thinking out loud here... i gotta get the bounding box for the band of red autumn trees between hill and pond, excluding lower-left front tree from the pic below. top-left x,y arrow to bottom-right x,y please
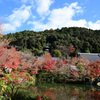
0,40 -> 100,82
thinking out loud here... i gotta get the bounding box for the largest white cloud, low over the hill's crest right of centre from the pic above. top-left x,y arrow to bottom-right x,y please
28,2 -> 87,30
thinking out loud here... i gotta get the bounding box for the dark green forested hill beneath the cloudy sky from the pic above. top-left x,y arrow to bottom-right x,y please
4,27 -> 100,55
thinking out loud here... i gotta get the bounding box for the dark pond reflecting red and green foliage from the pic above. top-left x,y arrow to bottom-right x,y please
36,83 -> 100,100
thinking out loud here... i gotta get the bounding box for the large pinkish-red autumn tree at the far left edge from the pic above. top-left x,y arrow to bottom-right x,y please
0,40 -> 21,70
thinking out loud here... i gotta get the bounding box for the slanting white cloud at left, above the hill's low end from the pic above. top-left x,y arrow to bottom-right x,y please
4,5 -> 31,31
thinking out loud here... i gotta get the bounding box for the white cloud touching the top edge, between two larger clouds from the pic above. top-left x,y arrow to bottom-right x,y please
35,0 -> 53,16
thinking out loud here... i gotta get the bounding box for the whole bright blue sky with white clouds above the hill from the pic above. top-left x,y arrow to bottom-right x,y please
0,0 -> 100,34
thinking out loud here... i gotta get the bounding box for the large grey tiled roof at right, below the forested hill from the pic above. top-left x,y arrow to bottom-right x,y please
78,53 -> 100,62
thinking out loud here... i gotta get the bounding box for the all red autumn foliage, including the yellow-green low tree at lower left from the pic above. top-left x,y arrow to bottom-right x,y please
0,40 -> 100,100
